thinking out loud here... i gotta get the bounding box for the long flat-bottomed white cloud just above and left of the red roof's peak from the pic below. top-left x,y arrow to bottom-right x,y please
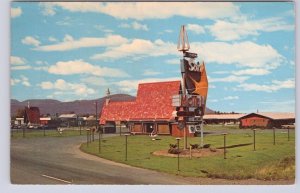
48,60 -> 129,77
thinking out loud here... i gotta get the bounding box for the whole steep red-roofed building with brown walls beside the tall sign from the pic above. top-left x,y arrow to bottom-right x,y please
99,80 -> 194,137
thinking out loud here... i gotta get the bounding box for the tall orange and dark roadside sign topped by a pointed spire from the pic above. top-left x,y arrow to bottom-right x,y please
173,25 -> 208,149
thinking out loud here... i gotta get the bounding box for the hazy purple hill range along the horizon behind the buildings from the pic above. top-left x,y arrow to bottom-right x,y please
10,94 -> 215,115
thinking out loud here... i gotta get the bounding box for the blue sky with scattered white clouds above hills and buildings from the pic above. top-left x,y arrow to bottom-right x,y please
10,2 -> 295,112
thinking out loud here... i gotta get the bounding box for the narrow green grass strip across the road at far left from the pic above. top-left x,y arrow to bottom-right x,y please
11,129 -> 90,139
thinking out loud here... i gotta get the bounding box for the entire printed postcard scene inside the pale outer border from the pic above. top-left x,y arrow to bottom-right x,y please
10,1 -> 296,185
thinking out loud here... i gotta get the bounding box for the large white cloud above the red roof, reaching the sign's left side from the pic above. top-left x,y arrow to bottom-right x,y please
91,39 -> 179,59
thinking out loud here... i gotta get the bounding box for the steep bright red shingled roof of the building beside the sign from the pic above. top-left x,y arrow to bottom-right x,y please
100,81 -> 180,124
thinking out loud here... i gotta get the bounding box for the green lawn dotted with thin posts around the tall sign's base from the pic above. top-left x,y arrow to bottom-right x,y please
81,127 -> 295,180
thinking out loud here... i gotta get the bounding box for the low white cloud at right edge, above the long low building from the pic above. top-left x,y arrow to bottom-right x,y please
238,79 -> 295,92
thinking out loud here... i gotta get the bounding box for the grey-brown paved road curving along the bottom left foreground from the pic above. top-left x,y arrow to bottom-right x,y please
11,133 -> 289,184
